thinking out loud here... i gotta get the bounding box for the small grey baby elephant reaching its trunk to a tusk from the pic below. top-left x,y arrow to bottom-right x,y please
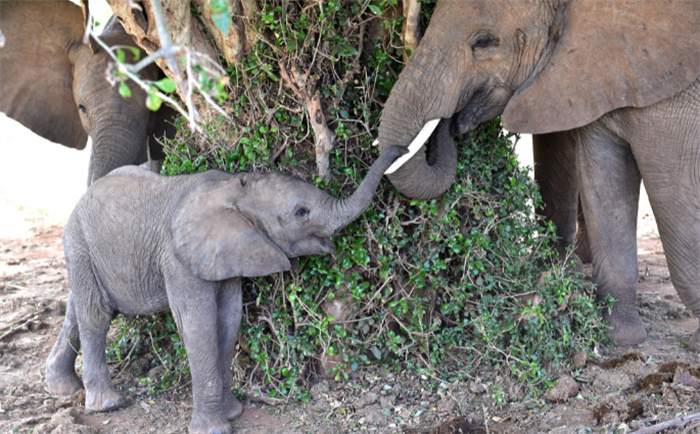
46,148 -> 404,433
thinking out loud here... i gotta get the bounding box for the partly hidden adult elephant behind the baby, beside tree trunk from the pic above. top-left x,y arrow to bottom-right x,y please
0,0 -> 176,185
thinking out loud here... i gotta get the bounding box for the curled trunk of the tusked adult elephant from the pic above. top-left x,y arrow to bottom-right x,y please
378,28 -> 463,199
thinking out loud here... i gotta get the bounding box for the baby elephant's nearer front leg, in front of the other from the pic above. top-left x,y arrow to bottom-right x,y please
166,267 -> 231,434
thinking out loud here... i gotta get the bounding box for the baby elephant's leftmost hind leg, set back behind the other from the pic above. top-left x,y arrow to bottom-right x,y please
46,294 -> 83,395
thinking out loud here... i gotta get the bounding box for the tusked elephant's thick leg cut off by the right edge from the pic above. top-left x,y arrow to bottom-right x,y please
628,92 -> 700,352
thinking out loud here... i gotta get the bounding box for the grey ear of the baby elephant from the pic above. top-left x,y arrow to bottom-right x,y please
171,178 -> 291,281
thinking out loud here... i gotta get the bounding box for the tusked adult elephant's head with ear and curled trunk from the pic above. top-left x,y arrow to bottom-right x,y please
378,0 -> 700,199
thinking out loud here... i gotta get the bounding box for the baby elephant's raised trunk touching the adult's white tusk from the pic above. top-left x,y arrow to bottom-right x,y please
325,146 -> 405,233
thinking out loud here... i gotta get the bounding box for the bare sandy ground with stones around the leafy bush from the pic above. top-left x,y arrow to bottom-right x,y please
0,119 -> 700,434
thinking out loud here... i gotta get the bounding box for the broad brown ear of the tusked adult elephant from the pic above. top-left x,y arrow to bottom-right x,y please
503,0 -> 700,133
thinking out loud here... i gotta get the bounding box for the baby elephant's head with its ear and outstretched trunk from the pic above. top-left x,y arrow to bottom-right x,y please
171,147 -> 405,280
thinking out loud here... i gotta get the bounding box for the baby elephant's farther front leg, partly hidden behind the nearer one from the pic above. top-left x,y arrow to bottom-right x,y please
217,277 -> 243,420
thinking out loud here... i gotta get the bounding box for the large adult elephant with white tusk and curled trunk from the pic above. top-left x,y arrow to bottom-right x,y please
378,0 -> 700,351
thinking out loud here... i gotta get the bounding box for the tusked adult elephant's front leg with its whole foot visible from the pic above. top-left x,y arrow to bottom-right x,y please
575,122 -> 647,345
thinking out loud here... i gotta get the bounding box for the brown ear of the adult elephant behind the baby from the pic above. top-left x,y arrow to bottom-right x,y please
0,1 -> 88,149
